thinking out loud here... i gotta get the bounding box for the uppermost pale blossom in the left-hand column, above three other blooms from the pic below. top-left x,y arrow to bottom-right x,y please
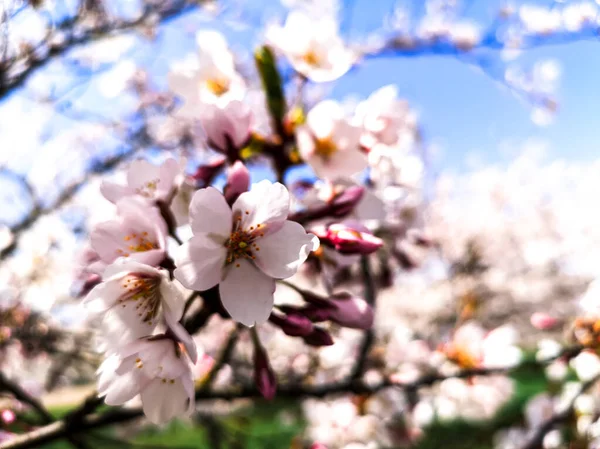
100,159 -> 181,203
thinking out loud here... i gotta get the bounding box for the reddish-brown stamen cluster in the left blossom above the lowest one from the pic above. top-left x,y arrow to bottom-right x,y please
119,273 -> 161,326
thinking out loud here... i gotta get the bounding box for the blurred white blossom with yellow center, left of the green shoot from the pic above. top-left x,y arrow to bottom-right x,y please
168,31 -> 246,114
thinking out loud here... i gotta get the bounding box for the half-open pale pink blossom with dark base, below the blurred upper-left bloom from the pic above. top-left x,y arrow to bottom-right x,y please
200,100 -> 252,155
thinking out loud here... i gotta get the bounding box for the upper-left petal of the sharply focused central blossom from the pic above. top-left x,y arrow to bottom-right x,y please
190,187 -> 232,241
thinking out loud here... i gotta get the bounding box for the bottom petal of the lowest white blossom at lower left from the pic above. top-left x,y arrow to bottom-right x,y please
140,379 -> 189,424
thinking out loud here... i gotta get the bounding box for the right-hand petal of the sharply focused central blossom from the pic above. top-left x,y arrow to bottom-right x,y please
255,221 -> 319,279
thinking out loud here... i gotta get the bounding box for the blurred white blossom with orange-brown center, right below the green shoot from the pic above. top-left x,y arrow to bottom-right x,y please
296,100 -> 367,180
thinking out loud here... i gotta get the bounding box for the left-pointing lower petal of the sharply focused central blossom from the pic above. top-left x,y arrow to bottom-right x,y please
174,235 -> 227,291
